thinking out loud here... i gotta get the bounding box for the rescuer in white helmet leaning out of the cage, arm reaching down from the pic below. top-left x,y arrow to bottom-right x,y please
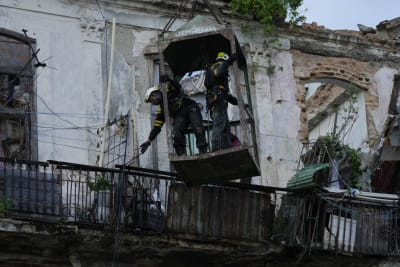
140,75 -> 207,156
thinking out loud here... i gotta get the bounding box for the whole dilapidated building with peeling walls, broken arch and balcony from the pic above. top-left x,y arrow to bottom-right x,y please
0,0 -> 400,266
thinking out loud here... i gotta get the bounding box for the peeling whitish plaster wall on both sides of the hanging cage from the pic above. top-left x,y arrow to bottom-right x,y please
0,0 -> 300,186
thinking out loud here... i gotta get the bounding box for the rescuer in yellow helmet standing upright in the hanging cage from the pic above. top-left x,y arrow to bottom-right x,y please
204,52 -> 238,151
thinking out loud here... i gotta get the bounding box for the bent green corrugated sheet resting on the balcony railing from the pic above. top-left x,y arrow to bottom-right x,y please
286,163 -> 330,189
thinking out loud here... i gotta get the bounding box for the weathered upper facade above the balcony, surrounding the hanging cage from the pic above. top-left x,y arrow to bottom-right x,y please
0,0 -> 400,266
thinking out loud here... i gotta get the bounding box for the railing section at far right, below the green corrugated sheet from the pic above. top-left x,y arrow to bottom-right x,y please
281,194 -> 400,256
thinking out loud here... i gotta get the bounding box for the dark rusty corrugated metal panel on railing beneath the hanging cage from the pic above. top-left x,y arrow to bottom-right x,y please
167,184 -> 275,241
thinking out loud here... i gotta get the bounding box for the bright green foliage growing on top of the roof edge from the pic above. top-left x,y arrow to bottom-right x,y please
231,0 -> 306,34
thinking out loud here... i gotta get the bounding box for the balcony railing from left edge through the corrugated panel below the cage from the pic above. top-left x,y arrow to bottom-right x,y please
0,158 -> 275,241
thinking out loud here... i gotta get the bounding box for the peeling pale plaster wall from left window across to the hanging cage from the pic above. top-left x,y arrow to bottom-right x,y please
0,0 -> 175,168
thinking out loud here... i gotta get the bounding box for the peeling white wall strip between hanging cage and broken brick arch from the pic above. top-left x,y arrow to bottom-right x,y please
248,39 -> 301,187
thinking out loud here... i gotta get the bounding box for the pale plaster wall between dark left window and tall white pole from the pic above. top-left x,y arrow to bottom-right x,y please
0,1 -> 102,162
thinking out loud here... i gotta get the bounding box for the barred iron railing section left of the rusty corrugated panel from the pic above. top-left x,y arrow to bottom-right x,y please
0,158 -> 175,231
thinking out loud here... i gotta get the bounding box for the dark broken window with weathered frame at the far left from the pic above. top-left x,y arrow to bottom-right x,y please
0,28 -> 38,160
